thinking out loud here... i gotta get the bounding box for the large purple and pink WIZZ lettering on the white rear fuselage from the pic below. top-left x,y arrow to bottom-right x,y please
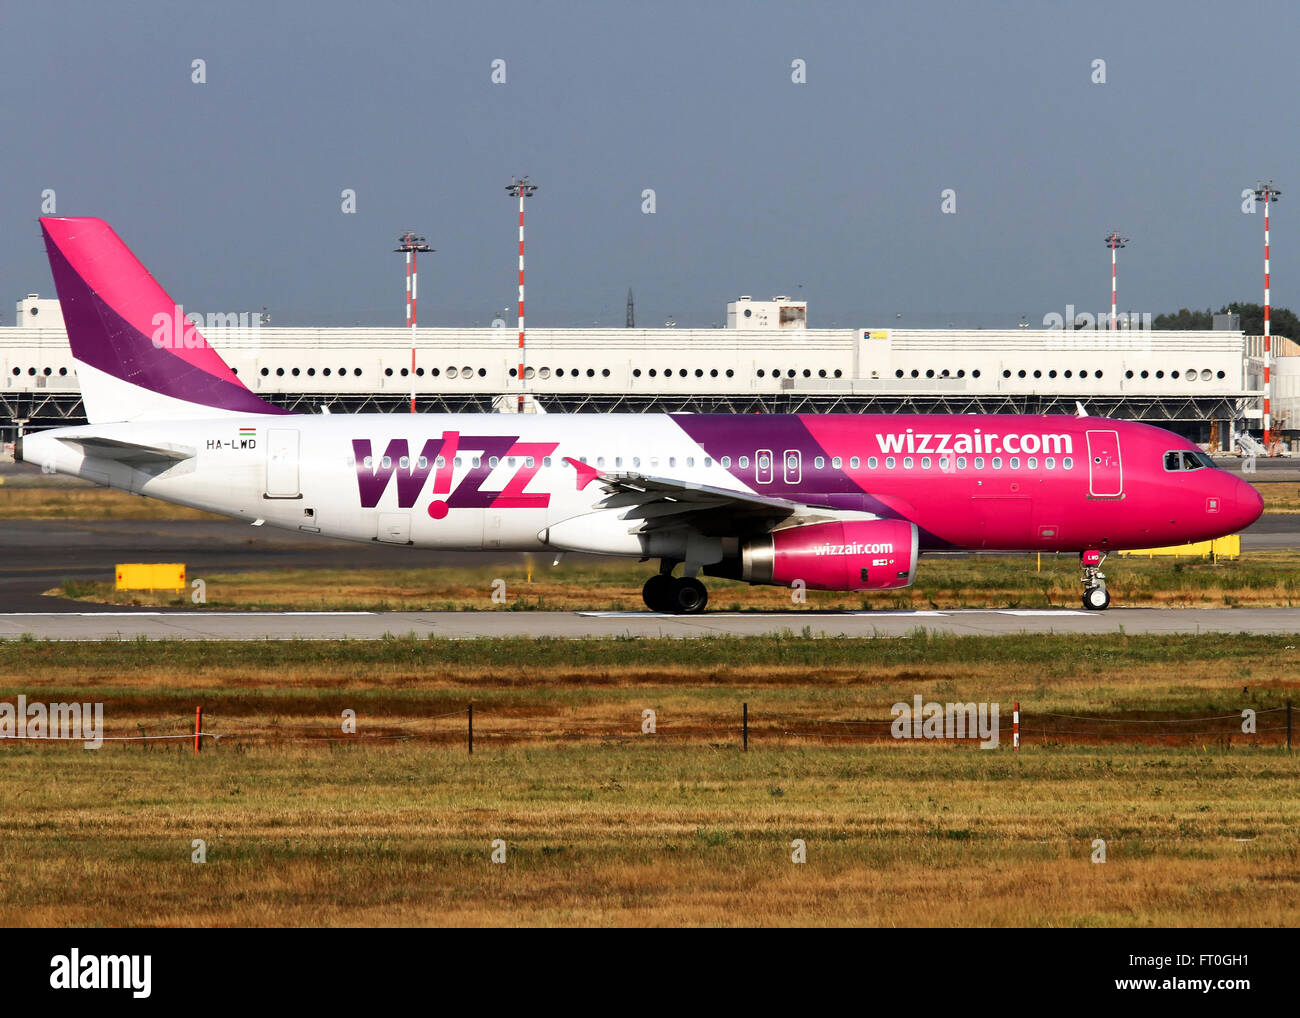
352,432 -> 559,519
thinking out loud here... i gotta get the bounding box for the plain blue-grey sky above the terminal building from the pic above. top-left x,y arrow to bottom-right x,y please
0,0 -> 1300,328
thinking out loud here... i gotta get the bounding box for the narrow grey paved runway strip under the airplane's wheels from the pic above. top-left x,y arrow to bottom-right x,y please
0,606 -> 1300,642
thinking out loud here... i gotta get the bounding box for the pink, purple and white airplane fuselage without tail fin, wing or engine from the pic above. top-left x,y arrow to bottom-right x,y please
22,413 -> 1262,555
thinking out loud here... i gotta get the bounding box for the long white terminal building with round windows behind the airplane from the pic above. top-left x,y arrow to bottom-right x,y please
0,294 -> 1284,450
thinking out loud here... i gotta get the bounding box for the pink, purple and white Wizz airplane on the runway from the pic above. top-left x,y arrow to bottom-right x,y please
18,217 -> 1262,614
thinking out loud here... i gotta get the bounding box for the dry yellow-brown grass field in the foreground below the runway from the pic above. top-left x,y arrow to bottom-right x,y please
0,636 -> 1300,926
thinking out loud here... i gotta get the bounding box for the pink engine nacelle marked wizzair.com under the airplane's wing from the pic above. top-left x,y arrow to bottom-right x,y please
740,520 -> 918,590
